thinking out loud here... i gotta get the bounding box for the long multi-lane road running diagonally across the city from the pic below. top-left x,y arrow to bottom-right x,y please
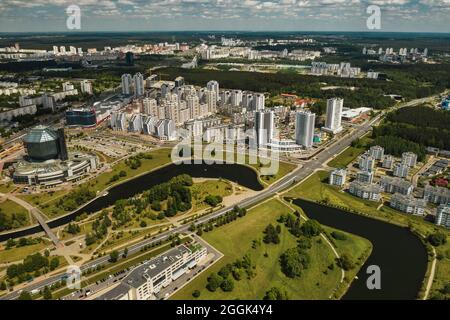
0,98 -> 436,300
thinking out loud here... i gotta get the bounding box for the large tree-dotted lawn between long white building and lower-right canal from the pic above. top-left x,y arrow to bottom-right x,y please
172,199 -> 340,300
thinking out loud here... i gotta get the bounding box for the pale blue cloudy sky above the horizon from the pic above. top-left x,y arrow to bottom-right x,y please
0,0 -> 450,33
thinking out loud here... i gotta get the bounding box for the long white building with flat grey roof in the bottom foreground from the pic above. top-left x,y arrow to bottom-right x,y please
98,244 -> 207,300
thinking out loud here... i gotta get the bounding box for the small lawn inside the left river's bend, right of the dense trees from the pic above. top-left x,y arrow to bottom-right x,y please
190,179 -> 233,211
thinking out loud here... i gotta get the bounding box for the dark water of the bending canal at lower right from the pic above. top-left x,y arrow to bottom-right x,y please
294,199 -> 427,300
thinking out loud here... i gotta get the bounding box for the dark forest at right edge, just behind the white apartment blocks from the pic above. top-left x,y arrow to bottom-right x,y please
373,106 -> 450,150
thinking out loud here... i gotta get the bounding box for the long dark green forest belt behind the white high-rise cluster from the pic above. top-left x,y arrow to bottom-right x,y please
157,64 -> 450,109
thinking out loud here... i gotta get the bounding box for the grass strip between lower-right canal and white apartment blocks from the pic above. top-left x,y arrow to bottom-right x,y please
285,171 -> 450,298
